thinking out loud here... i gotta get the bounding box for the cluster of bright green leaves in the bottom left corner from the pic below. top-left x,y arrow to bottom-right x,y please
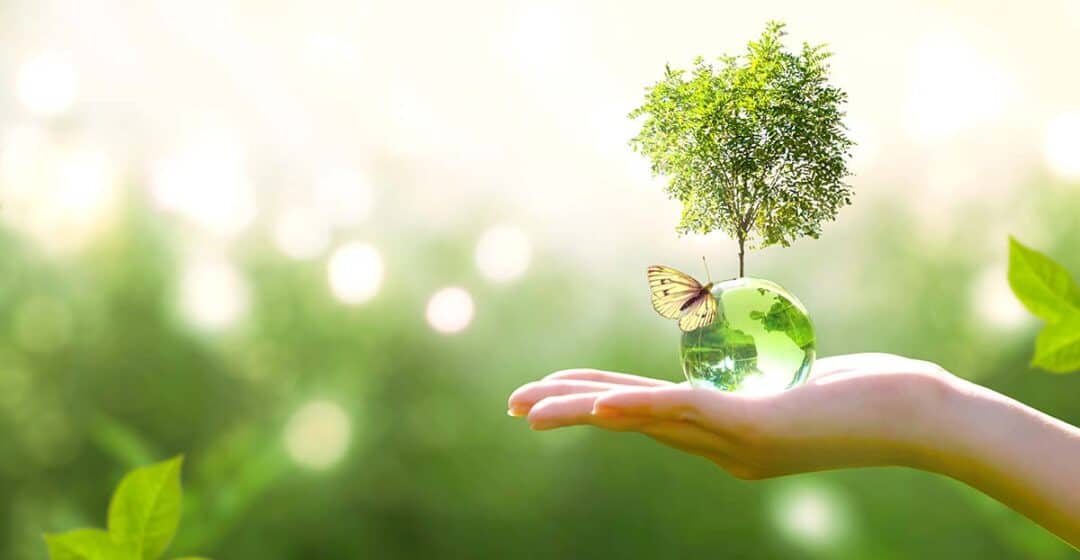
45,456 -> 206,560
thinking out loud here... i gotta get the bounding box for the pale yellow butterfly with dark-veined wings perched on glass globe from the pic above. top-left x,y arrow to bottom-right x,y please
648,264 -> 717,332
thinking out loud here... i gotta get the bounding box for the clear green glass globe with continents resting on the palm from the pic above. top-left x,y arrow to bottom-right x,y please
681,277 -> 814,393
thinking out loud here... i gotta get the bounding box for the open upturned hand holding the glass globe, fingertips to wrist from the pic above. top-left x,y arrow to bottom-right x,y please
509,354 -> 954,479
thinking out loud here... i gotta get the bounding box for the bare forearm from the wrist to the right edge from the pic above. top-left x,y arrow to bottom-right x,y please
924,380 -> 1080,547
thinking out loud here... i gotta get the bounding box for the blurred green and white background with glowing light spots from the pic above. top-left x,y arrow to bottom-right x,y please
0,1 -> 1080,559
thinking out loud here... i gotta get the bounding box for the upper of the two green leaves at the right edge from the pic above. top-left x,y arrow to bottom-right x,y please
1009,237 -> 1080,323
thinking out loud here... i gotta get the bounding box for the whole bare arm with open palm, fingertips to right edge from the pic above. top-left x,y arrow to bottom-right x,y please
508,354 -> 1080,548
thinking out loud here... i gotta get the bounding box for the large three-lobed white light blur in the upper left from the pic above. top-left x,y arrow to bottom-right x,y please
150,127 -> 256,237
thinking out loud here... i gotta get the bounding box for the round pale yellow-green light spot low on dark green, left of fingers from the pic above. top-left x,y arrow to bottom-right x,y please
285,400 -> 352,470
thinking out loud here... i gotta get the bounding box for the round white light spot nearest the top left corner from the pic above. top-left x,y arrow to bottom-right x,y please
16,53 -> 79,117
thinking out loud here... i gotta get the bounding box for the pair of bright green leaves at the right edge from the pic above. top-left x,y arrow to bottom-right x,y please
1009,237 -> 1080,373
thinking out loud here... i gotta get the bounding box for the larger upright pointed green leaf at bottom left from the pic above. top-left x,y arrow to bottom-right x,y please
109,456 -> 184,560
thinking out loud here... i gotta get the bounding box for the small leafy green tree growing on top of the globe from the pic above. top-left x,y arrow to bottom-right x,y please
630,22 -> 854,276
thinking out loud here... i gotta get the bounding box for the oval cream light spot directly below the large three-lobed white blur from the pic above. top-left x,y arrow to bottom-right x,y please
180,255 -> 249,330
